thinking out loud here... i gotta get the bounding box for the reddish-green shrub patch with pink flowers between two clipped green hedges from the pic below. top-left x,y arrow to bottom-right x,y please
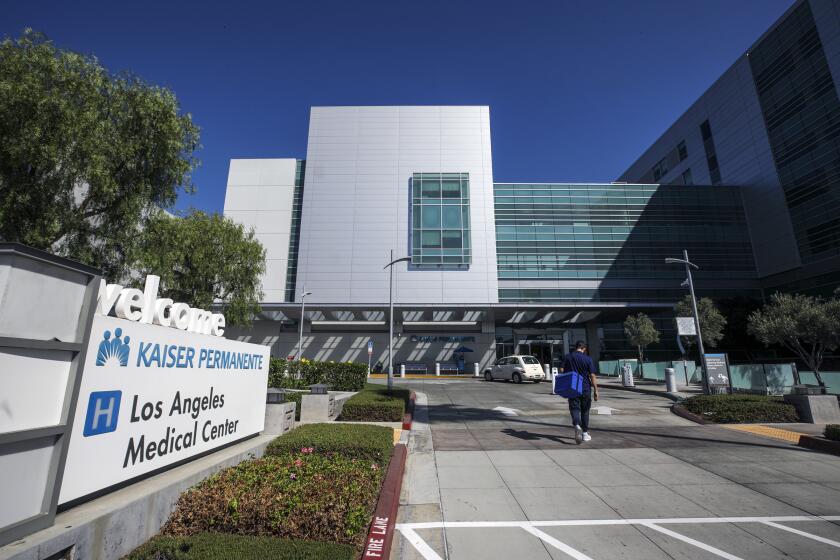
161,450 -> 384,548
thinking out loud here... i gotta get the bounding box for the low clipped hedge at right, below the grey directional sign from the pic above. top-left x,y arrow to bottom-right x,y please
682,395 -> 799,424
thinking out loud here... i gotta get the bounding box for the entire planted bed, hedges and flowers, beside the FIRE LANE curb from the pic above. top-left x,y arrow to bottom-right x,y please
128,424 -> 394,560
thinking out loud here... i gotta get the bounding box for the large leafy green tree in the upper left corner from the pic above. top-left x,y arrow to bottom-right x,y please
0,29 -> 199,280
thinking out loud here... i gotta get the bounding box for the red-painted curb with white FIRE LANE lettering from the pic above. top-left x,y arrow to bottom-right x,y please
362,443 -> 408,560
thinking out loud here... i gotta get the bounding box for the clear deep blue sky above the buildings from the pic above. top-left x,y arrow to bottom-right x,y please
0,0 -> 793,211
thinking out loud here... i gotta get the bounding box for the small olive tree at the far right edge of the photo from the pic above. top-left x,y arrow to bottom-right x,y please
748,292 -> 840,393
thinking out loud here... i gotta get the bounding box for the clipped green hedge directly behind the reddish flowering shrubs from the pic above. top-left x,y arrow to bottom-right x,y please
265,424 -> 394,466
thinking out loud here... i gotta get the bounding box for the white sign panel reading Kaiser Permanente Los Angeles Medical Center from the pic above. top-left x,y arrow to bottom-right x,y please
59,312 -> 269,503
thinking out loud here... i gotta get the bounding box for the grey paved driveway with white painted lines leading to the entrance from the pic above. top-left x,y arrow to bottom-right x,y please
391,380 -> 840,560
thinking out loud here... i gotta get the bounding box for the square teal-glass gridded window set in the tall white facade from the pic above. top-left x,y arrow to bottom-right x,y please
411,173 -> 471,268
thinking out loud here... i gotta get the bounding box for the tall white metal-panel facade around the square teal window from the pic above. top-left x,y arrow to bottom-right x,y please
296,106 -> 498,304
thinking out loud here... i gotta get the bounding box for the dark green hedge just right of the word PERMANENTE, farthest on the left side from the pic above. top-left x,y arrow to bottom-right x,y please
268,358 -> 367,391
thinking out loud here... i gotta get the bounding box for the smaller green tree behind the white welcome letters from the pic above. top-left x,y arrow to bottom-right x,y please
133,211 -> 265,326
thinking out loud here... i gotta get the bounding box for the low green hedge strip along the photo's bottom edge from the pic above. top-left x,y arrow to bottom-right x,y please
125,533 -> 356,560
